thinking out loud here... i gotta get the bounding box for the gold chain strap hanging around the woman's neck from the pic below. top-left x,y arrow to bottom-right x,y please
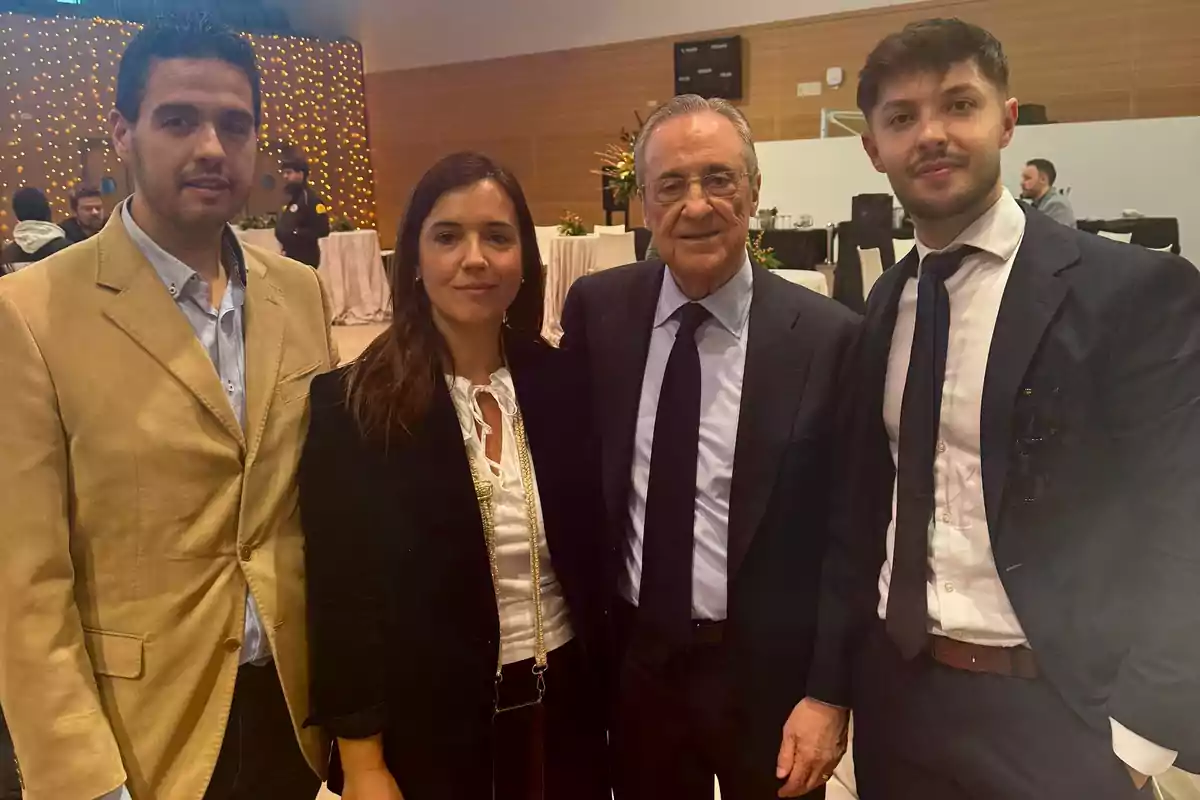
467,409 -> 547,686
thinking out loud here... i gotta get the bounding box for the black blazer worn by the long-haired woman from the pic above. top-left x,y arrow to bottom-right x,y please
299,333 -> 604,800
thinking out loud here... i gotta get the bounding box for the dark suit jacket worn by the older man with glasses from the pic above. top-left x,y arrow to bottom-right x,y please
563,261 -> 859,777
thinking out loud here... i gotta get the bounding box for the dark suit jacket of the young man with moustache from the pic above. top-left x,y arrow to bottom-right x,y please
817,211 -> 1200,770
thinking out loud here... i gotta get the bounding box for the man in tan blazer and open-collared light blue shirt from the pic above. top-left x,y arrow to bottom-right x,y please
0,15 -> 337,800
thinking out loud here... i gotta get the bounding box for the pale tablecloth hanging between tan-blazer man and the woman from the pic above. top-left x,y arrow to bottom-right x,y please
318,230 -> 391,325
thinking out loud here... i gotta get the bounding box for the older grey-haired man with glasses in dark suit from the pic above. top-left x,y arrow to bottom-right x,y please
563,96 -> 858,800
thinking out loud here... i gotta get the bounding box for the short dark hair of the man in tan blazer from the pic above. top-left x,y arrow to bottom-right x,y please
116,14 -> 263,127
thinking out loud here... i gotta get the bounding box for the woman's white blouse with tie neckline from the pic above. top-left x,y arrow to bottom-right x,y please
446,367 -> 574,664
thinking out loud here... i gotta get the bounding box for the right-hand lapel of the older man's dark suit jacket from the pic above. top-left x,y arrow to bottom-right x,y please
728,266 -> 812,582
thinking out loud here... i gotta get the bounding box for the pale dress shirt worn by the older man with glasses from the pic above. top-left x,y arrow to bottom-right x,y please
623,255 -> 754,620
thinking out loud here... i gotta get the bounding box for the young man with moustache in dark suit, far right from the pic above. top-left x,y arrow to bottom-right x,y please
801,14 -> 1200,800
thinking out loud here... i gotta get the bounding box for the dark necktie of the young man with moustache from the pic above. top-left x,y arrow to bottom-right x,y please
886,247 -> 978,658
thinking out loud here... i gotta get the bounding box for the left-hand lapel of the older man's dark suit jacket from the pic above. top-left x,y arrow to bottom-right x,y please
601,261 -> 666,530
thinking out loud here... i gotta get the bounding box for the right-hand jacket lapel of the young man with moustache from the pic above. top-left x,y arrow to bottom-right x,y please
979,213 -> 1080,537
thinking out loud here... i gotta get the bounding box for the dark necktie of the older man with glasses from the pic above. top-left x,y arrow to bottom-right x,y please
638,302 -> 709,643
